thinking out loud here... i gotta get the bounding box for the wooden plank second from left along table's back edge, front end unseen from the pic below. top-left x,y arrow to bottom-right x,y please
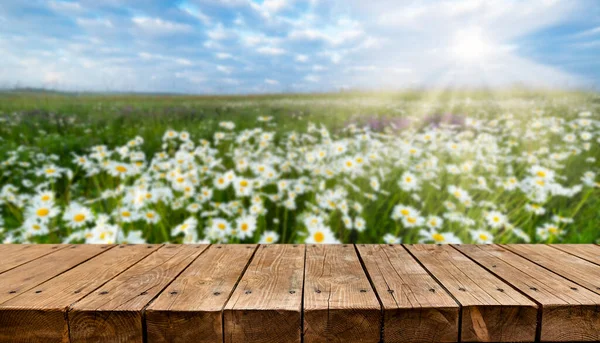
0,245 -> 112,304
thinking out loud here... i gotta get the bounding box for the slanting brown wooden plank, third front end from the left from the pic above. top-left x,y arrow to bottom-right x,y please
146,244 -> 257,343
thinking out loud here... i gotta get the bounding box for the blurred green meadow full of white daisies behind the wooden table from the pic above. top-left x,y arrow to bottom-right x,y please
0,93 -> 600,243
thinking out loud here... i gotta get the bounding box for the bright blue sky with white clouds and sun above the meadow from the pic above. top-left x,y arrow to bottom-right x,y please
0,0 -> 600,94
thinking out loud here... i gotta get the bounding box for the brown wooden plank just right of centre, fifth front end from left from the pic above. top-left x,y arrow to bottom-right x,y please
304,244 -> 382,342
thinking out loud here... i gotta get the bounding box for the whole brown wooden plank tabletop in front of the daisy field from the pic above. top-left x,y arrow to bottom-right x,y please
0,244 -> 600,343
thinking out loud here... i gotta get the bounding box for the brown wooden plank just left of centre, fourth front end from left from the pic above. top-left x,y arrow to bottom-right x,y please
223,244 -> 305,343
